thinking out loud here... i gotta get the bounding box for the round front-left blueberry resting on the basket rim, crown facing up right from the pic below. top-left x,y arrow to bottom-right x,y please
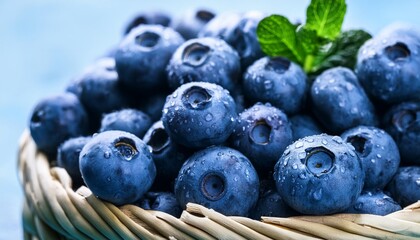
79,131 -> 156,205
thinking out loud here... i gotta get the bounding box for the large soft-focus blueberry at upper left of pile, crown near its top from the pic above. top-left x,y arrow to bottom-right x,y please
115,25 -> 184,94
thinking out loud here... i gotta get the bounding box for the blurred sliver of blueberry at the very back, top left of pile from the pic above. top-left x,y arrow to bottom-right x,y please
124,11 -> 171,35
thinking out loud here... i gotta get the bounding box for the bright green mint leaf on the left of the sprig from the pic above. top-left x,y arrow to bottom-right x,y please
257,15 -> 304,63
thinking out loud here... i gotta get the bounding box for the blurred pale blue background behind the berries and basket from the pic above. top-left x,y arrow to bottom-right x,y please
0,0 -> 420,239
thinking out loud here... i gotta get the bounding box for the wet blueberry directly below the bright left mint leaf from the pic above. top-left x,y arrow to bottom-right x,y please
243,57 -> 306,114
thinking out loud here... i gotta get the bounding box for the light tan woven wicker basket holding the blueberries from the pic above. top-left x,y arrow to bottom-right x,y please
18,131 -> 420,240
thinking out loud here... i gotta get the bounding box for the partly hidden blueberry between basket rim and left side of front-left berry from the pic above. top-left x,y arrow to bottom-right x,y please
57,137 -> 91,189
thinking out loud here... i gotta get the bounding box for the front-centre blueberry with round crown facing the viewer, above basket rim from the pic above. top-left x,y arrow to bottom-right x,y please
175,146 -> 259,216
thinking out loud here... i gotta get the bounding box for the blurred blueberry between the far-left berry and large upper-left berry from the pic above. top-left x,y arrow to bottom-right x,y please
66,58 -> 129,128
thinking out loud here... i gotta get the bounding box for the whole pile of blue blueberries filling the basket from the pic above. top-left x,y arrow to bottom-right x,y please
29,10 -> 420,219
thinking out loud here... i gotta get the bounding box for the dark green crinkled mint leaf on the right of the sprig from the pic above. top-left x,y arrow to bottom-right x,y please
311,30 -> 372,74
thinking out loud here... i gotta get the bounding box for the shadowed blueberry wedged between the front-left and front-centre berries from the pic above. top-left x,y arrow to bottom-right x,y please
143,121 -> 191,191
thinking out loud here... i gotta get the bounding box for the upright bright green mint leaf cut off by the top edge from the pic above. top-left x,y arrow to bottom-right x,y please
305,0 -> 347,40
